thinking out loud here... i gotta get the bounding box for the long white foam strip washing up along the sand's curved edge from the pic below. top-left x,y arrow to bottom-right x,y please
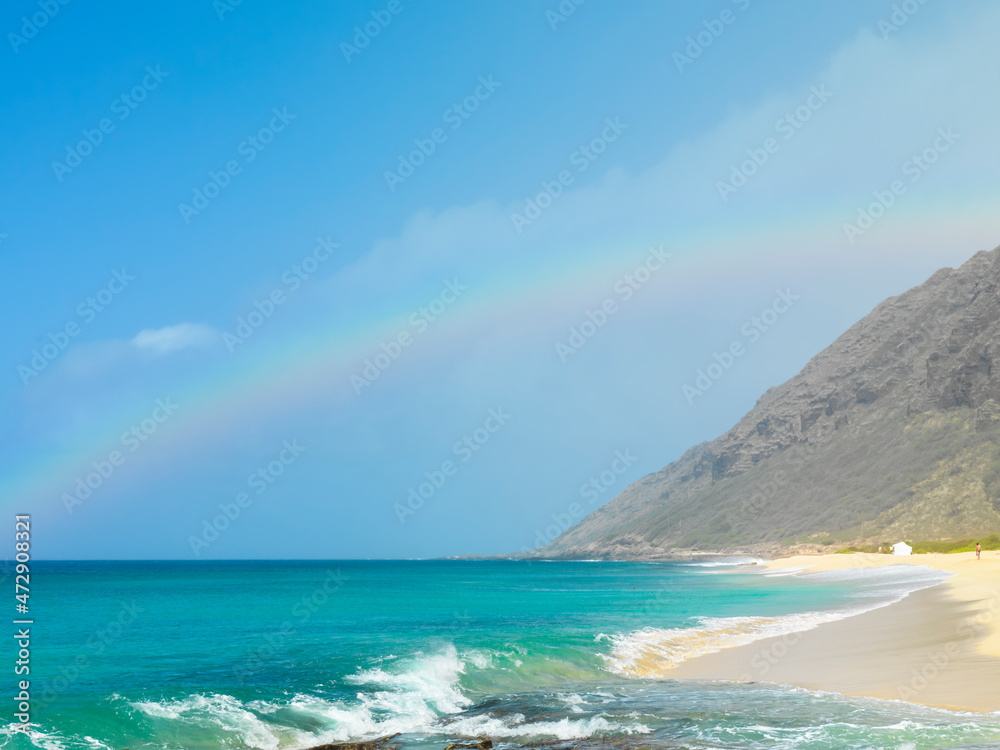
597,565 -> 951,677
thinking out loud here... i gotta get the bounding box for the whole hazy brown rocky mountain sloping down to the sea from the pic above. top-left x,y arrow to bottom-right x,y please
531,248 -> 1000,559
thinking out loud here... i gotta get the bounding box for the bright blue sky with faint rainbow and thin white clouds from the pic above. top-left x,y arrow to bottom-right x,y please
0,0 -> 1000,559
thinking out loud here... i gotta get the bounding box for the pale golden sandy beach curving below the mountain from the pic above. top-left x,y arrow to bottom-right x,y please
669,551 -> 1000,712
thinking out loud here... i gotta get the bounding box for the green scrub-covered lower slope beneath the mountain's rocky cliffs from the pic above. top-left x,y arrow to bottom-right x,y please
636,408 -> 1000,549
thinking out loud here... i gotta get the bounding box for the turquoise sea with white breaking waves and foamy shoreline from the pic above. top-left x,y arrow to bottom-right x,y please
2,561 -> 1000,750
